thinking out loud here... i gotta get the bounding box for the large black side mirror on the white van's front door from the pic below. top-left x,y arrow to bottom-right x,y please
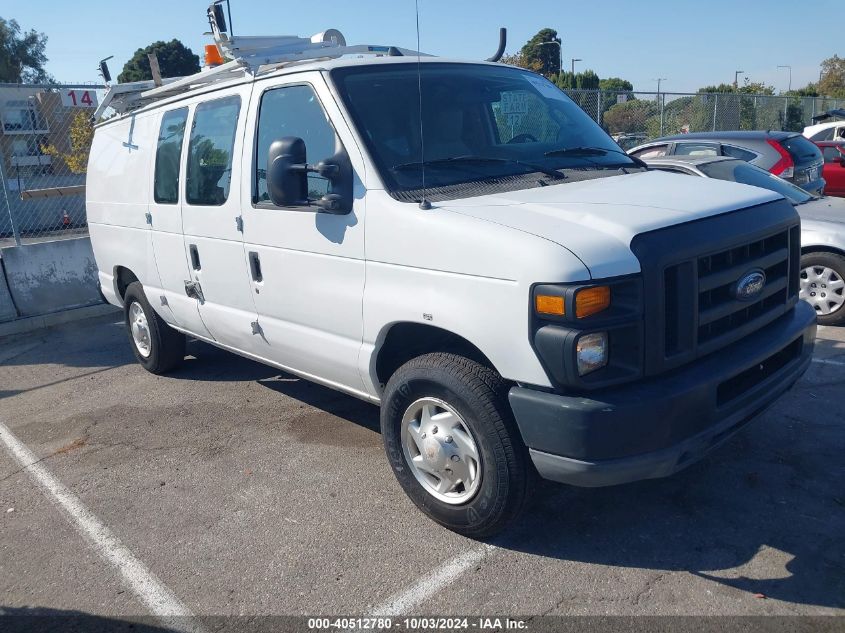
267,136 -> 352,215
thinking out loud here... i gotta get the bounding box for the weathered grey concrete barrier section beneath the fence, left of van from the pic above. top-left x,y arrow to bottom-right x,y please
0,237 -> 102,317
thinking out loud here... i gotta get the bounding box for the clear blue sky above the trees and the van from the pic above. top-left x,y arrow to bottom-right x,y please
6,0 -> 843,91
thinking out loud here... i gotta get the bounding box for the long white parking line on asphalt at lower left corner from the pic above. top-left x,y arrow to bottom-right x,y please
0,422 -> 206,633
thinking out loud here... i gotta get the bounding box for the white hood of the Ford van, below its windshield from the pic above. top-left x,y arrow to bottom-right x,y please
437,171 -> 781,279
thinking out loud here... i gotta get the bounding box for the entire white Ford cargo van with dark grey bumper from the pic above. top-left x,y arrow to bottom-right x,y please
87,14 -> 816,536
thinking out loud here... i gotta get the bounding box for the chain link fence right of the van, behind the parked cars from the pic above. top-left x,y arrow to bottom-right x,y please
565,90 -> 845,149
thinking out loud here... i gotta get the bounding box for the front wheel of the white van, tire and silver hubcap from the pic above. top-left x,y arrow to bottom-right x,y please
381,353 -> 533,538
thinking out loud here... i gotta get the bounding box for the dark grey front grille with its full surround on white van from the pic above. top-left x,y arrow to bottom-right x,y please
631,200 -> 801,376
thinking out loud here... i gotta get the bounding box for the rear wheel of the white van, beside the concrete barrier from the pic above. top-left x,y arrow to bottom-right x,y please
123,281 -> 185,375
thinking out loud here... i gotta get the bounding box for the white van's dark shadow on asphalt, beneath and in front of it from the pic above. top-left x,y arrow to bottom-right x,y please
176,341 -> 845,608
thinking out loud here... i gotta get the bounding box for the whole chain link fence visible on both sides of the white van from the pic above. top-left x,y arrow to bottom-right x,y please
0,84 -> 845,246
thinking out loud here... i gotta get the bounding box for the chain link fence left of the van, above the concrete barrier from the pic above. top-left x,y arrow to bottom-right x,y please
0,84 -> 105,246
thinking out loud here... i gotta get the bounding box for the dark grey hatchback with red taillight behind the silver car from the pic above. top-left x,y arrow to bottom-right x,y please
628,132 -> 825,194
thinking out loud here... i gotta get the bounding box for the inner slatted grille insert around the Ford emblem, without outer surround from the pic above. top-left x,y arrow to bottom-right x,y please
664,226 -> 800,357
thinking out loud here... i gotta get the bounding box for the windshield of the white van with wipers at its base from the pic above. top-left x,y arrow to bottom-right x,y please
331,61 -> 637,199
